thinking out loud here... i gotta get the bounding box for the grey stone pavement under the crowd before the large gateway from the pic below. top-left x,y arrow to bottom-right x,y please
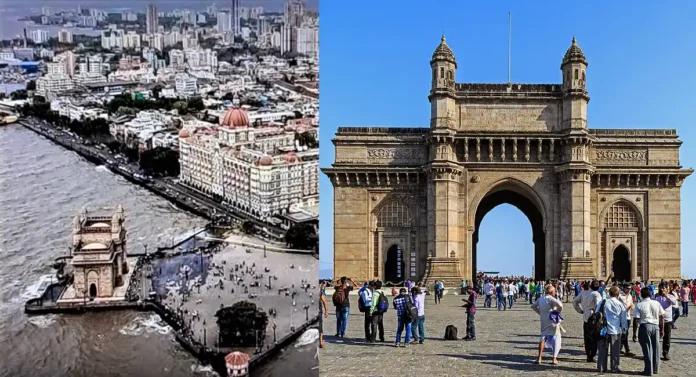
320,291 -> 696,377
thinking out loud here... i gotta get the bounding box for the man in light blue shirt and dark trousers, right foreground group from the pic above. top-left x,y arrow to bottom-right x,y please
595,286 -> 628,373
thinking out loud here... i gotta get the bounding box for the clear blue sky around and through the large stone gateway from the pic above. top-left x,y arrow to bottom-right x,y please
320,0 -> 696,277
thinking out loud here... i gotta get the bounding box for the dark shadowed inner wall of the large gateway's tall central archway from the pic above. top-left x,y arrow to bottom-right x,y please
472,190 -> 546,281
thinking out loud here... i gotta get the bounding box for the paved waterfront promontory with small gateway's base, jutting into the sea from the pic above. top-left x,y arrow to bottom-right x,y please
25,208 -> 318,376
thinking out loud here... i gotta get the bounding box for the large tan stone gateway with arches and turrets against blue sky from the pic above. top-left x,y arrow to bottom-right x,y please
323,36 -> 693,285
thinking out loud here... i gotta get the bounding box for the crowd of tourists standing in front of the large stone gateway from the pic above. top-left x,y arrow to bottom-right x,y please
322,274 -> 696,375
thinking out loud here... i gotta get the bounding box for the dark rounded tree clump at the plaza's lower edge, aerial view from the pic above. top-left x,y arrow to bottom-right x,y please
215,301 -> 268,347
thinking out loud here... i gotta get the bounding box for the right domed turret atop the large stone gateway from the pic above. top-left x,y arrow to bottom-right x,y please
561,37 -> 590,130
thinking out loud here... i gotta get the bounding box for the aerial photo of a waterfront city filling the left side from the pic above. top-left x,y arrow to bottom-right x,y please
0,0 -> 320,376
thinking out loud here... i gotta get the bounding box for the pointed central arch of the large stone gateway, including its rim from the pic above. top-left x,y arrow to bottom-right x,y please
471,178 -> 547,281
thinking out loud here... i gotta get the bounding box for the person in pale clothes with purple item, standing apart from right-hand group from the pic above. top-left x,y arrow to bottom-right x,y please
532,284 -> 563,365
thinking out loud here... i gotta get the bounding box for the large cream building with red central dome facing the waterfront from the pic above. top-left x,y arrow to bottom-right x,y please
179,109 -> 319,222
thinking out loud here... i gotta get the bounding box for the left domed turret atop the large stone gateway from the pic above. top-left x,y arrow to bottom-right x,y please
428,35 -> 457,128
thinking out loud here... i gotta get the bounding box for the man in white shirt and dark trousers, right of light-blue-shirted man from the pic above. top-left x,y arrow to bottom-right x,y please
633,287 -> 665,376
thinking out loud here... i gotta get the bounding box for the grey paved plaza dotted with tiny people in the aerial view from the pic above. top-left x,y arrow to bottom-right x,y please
153,236 -> 318,352
